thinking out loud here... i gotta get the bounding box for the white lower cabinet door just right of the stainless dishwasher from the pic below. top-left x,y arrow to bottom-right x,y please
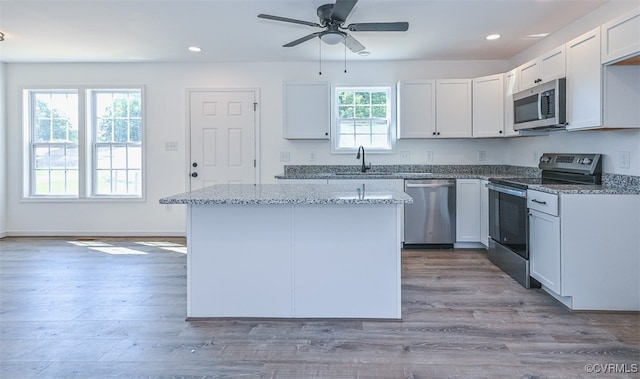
456,179 -> 481,242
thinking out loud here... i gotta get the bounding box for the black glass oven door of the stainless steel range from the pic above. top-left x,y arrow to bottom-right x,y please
487,183 -> 529,259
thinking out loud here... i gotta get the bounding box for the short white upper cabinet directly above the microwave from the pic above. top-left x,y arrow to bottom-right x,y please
517,45 -> 566,91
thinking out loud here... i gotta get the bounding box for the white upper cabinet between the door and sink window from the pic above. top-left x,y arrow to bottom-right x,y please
283,82 -> 331,139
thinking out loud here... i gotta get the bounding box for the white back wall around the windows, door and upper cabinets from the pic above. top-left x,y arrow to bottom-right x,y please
3,61 -> 507,235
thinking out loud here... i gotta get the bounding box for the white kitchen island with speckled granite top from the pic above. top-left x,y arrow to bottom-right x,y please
160,184 -> 412,319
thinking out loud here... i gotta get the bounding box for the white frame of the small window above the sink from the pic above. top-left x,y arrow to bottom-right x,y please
331,83 -> 397,154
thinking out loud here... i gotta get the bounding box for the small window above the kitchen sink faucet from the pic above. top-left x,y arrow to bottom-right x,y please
332,86 -> 395,152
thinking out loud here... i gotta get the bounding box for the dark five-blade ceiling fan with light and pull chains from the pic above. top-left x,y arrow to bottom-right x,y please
258,0 -> 409,53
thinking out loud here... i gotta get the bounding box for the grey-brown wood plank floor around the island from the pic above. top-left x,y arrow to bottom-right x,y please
0,238 -> 640,379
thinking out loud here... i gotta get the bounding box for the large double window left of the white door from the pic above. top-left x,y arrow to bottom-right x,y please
24,88 -> 143,198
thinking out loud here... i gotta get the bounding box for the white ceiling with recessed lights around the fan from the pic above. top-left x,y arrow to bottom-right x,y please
0,0 -> 624,62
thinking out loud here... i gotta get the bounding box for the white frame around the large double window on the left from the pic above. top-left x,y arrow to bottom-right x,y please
19,84 -> 147,202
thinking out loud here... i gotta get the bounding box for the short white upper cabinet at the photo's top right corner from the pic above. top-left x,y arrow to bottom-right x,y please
601,8 -> 640,63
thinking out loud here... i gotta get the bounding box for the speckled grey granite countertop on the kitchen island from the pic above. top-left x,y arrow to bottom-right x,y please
160,184 -> 413,204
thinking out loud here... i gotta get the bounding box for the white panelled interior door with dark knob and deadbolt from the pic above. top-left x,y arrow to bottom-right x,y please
189,90 -> 257,190
